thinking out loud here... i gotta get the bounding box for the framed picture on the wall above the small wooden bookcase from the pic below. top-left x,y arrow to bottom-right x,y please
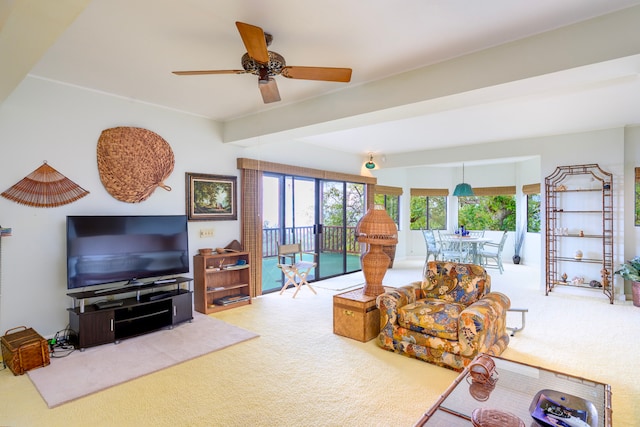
185,172 -> 238,221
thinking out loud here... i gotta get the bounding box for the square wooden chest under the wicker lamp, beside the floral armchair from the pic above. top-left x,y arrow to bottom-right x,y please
333,288 -> 380,342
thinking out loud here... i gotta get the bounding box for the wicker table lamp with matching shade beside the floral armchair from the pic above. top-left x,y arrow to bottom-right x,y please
356,205 -> 398,296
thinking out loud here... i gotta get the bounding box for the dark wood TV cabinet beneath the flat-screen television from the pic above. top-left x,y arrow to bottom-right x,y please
67,277 -> 193,350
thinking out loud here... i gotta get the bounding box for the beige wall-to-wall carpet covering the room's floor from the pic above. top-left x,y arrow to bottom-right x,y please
0,260 -> 640,427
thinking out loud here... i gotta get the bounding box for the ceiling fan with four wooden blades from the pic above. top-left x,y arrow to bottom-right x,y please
173,22 -> 351,104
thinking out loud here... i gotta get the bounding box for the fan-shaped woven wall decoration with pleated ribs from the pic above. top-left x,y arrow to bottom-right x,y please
2,161 -> 89,208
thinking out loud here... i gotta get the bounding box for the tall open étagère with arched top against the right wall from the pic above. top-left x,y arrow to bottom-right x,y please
545,164 -> 614,304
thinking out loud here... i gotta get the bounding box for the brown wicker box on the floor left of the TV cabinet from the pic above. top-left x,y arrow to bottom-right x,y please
0,326 -> 49,375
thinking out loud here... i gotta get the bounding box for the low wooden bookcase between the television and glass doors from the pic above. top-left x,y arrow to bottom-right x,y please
193,252 -> 251,314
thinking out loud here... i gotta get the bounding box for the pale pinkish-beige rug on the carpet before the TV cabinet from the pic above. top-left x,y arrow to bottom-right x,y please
27,313 -> 258,408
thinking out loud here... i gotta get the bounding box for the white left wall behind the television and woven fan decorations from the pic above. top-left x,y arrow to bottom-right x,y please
0,77 -> 361,336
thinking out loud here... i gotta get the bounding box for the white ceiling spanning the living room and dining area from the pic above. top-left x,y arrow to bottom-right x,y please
0,0 -> 640,154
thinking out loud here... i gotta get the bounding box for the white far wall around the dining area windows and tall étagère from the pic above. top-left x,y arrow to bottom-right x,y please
375,127 -> 640,299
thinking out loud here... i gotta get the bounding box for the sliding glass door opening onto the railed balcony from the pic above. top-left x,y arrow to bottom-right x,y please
262,173 -> 365,293
